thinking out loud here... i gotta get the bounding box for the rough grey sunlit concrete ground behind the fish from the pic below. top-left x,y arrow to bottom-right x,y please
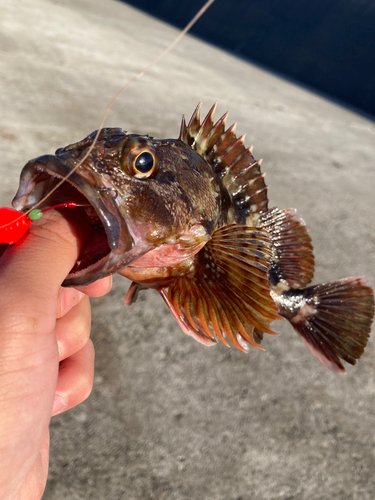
0,0 -> 375,500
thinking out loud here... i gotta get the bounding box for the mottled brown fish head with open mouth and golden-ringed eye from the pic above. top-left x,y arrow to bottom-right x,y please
13,128 -> 222,286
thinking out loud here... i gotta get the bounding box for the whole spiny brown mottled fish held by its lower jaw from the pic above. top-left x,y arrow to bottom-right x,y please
12,103 -> 375,373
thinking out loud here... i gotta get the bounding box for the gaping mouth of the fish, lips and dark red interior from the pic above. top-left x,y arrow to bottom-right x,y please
12,155 -> 133,286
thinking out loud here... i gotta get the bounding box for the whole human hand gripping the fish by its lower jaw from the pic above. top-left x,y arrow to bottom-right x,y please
0,212 -> 111,500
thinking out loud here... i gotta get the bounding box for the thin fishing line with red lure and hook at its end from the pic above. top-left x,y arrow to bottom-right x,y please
0,0 -> 215,244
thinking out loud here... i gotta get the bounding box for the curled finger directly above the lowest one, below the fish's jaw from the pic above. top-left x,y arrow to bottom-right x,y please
55,296 -> 91,361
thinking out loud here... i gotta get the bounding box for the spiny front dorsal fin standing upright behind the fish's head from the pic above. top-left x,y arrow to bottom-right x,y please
179,102 -> 268,221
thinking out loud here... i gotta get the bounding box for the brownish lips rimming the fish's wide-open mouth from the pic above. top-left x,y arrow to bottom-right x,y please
12,155 -> 134,286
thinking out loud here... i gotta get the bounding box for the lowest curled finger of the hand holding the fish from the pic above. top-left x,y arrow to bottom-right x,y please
52,340 -> 95,415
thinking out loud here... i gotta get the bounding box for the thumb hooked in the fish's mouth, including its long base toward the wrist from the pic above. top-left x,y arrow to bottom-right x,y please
0,212 -> 85,498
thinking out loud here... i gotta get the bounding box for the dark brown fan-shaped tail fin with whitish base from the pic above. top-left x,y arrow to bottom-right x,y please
275,276 -> 374,373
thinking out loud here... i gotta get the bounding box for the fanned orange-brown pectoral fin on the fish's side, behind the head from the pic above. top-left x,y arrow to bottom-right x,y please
159,224 -> 282,351
